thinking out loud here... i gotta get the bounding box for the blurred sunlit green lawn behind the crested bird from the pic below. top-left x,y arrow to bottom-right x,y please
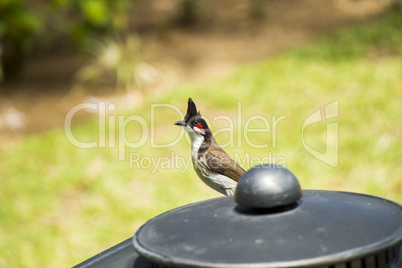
0,9 -> 402,267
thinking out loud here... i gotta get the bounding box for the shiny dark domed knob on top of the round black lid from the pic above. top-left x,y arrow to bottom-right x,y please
234,164 -> 302,208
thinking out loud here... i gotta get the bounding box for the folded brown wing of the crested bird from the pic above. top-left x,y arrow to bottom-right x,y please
204,143 -> 246,181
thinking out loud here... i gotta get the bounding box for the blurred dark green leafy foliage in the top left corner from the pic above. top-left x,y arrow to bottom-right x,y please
0,0 -> 131,81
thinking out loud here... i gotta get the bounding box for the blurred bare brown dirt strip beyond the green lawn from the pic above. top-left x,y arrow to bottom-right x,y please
0,0 -> 389,144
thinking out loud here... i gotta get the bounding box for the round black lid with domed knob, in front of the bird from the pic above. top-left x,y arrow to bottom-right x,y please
133,165 -> 402,268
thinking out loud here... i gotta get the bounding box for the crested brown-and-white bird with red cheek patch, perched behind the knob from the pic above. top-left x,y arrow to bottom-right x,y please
174,98 -> 246,196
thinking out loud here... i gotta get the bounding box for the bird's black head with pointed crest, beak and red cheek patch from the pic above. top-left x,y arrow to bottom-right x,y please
174,98 -> 210,135
